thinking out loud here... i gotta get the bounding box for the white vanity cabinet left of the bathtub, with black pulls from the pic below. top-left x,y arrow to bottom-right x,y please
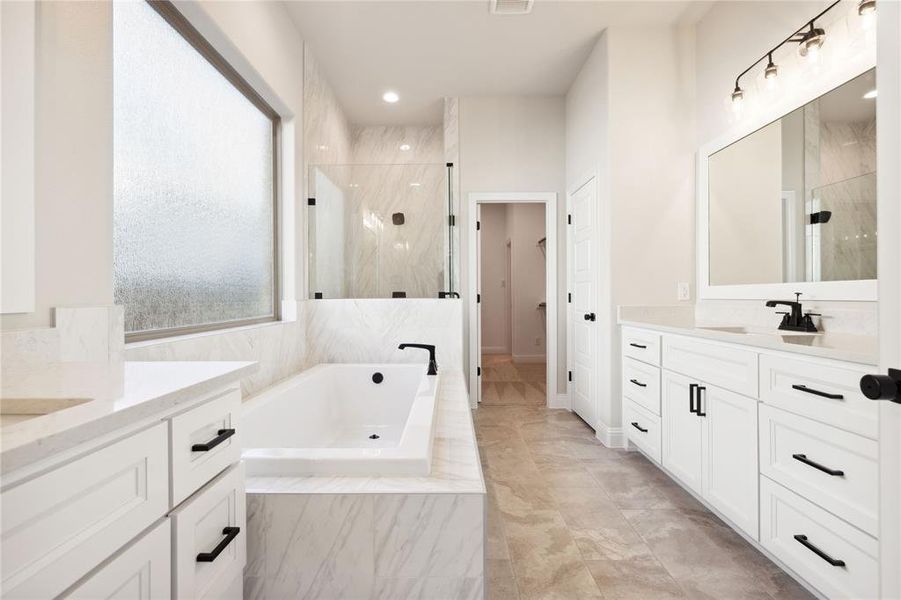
0,388 -> 246,600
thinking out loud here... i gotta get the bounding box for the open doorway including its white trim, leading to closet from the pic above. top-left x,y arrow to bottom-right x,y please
470,194 -> 557,406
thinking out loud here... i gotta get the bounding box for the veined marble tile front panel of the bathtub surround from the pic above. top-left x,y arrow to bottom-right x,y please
244,494 -> 485,600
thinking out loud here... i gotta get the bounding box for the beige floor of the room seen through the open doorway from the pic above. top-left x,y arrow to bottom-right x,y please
482,354 -> 547,406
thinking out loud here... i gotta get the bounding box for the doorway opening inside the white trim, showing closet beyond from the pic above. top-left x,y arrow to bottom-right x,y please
479,203 -> 547,406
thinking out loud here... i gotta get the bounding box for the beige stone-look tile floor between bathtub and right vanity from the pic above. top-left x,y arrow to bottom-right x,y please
474,403 -> 811,600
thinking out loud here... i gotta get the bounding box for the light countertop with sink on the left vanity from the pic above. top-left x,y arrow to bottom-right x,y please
0,361 -> 257,474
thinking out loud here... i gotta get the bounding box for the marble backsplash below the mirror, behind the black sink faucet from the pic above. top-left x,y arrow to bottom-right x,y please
694,295 -> 879,337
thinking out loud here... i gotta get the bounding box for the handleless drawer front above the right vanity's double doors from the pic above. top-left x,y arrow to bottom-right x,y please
663,335 -> 757,398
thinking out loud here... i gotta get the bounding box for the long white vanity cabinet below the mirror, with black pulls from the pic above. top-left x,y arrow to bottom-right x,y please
622,326 -> 879,598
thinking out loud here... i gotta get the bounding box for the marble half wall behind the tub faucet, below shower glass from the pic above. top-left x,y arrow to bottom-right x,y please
303,298 -> 463,369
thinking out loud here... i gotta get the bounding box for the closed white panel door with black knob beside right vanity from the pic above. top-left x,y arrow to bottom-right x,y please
567,179 -> 598,428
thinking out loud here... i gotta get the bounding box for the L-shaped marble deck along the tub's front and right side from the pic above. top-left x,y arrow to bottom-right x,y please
246,369 -> 486,494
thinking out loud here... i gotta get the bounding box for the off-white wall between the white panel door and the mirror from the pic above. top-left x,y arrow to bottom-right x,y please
566,28 -> 696,443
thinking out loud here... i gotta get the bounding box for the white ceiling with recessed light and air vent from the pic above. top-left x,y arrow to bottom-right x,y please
286,0 -> 712,125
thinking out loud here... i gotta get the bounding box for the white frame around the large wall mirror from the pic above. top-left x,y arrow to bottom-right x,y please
697,43 -> 878,301
